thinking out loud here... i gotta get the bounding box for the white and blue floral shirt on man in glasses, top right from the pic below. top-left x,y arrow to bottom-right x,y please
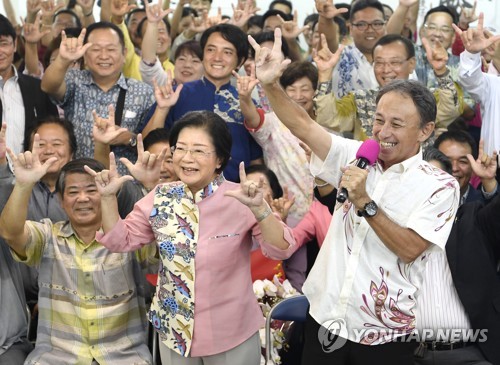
332,45 -> 378,98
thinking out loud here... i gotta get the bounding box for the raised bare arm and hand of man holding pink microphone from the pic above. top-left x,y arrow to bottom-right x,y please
248,28 -> 332,160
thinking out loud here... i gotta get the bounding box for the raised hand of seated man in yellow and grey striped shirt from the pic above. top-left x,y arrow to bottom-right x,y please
6,133 -> 57,185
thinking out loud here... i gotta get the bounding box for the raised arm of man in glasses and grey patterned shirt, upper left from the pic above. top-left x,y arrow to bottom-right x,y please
41,28 -> 92,101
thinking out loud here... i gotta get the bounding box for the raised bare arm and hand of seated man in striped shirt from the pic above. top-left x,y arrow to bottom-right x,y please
0,134 -> 57,257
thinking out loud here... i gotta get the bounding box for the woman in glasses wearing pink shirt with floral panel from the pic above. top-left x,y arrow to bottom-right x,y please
87,111 -> 295,365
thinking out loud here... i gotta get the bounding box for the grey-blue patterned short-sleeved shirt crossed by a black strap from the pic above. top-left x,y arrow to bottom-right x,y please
61,70 -> 154,174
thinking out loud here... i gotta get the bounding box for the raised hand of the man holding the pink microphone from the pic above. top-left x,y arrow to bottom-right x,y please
248,28 -> 291,85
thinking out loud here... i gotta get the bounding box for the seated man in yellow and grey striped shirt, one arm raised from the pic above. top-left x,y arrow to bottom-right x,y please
0,146 -> 156,365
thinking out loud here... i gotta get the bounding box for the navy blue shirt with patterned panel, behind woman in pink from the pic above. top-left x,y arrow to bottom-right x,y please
141,77 -> 262,182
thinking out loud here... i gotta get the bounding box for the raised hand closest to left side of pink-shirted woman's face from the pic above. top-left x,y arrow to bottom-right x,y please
120,134 -> 167,189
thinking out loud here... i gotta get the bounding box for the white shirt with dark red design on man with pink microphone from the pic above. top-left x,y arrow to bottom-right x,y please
303,135 -> 459,345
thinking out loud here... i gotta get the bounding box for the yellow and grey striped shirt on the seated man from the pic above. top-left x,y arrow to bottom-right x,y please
11,219 -> 156,365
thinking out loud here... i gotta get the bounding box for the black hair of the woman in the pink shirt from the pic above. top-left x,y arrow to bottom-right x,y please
169,110 -> 232,173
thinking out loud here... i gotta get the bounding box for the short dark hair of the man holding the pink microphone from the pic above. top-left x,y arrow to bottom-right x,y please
376,80 -> 437,129
